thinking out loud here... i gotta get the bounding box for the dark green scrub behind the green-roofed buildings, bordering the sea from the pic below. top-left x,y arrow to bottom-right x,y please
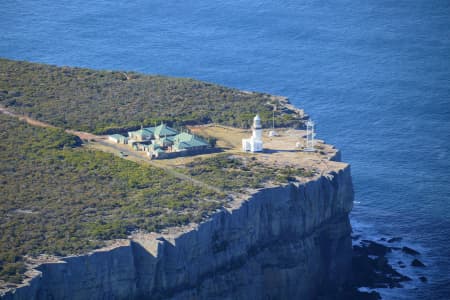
0,59 -> 303,134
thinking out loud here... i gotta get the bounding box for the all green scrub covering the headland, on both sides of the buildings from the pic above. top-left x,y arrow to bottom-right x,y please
0,59 -> 313,283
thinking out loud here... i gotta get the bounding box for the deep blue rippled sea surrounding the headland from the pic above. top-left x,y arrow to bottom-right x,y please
0,0 -> 450,299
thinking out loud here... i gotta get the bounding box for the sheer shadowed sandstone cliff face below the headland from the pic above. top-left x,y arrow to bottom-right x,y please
2,164 -> 353,300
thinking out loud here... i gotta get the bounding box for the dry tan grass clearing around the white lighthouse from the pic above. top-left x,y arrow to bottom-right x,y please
90,125 -> 342,178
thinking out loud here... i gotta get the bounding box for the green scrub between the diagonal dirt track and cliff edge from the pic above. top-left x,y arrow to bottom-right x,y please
0,115 -> 225,282
